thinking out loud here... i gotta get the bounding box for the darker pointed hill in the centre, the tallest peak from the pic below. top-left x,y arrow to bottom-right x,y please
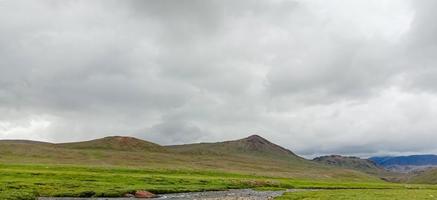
167,135 -> 303,159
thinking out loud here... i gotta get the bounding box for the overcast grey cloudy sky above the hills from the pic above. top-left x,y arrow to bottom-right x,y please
0,0 -> 437,157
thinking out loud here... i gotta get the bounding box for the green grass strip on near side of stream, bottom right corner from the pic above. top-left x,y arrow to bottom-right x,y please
276,189 -> 437,200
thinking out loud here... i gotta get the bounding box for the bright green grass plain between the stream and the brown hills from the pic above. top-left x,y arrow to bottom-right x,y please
0,164 -> 433,199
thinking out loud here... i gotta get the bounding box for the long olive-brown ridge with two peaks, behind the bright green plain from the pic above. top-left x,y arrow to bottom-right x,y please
0,135 -> 378,181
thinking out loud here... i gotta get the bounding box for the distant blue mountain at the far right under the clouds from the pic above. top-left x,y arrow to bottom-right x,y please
369,154 -> 437,172
